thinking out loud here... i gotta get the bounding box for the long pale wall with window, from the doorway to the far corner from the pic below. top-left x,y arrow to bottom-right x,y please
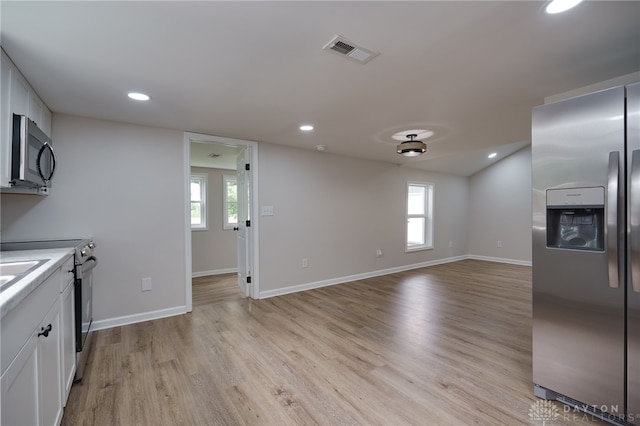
259,144 -> 468,293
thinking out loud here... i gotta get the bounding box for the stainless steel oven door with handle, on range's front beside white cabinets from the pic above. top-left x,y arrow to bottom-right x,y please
75,256 -> 98,352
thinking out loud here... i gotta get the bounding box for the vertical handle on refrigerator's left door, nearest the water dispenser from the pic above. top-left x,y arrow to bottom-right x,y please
606,151 -> 620,288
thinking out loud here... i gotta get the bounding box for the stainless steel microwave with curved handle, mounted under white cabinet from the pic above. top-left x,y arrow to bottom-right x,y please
10,114 -> 56,191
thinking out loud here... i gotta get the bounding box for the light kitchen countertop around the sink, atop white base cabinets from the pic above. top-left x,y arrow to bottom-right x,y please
0,247 -> 74,318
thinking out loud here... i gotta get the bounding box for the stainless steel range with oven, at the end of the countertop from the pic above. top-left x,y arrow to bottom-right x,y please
0,238 -> 98,381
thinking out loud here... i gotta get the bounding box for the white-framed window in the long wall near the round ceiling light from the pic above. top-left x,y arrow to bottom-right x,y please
405,182 -> 433,251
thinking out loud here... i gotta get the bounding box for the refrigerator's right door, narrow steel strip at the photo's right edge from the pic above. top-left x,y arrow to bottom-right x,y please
627,83 -> 640,420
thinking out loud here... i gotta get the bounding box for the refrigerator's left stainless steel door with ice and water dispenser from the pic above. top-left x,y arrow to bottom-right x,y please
532,87 -> 626,413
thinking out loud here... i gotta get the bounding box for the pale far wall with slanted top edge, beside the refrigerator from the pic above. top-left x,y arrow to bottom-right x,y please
469,146 -> 531,264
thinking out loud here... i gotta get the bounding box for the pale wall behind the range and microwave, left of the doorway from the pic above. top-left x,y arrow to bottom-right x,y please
1,114 -> 186,324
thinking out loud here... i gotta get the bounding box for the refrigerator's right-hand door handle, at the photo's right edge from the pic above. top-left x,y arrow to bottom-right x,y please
628,149 -> 640,293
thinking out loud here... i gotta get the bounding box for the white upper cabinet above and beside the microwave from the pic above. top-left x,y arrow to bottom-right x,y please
0,49 -> 51,188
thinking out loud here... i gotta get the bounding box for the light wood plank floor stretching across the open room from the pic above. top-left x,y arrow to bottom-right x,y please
62,260 -> 604,426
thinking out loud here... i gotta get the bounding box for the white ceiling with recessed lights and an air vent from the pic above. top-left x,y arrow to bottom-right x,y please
0,0 -> 640,176
